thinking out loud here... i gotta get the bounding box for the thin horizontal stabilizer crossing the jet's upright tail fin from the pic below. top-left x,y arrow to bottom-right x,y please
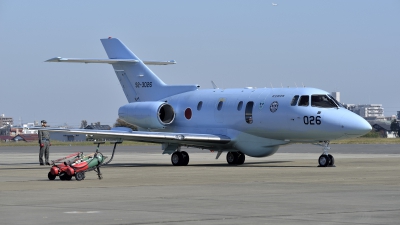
45,57 -> 176,65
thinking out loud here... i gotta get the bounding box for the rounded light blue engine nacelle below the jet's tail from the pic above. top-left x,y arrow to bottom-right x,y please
118,102 -> 175,129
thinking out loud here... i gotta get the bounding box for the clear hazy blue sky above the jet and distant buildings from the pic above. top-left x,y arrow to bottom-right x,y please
0,0 -> 400,126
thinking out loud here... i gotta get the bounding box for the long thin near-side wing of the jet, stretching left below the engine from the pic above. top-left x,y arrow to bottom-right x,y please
38,128 -> 231,148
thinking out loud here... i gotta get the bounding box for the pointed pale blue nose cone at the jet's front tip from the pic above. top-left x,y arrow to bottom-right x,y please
342,111 -> 372,138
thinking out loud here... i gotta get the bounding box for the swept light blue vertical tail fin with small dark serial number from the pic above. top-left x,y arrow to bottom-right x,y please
101,38 -> 198,102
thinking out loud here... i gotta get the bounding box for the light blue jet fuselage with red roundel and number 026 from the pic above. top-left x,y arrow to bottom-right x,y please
120,88 -> 370,157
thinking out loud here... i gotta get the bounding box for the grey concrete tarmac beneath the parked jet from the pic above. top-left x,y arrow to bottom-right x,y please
0,144 -> 400,225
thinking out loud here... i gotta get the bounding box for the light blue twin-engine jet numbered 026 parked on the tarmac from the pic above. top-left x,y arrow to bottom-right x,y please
45,37 -> 372,167
